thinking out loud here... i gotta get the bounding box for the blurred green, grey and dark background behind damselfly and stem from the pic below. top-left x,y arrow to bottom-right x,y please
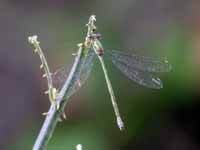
0,0 -> 200,150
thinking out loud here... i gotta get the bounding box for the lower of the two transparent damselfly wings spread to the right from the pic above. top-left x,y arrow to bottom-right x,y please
112,59 -> 162,89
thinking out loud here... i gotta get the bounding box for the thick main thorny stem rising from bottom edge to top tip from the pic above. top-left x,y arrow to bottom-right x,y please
29,15 -> 96,150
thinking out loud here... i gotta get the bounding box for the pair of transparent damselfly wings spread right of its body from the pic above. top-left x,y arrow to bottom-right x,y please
105,50 -> 171,89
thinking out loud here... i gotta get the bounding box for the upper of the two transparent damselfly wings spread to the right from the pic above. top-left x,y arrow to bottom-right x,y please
105,50 -> 172,72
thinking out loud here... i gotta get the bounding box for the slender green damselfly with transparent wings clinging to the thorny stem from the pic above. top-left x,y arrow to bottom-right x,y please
52,16 -> 171,129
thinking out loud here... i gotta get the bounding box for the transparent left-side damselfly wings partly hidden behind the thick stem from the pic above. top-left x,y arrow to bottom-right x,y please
52,50 -> 96,96
